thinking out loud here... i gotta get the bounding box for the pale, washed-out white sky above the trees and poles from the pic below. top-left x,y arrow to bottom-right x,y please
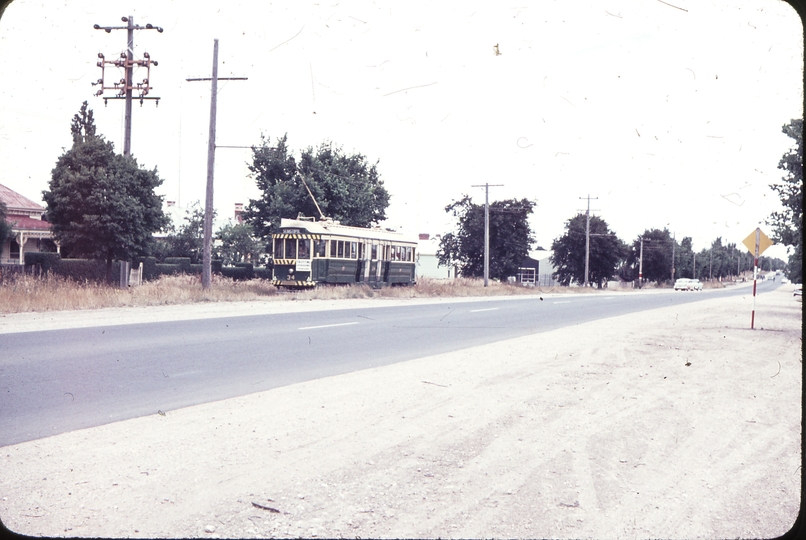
0,0 -> 804,259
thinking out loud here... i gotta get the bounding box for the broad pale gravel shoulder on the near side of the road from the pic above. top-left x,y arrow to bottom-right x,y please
0,286 -> 803,538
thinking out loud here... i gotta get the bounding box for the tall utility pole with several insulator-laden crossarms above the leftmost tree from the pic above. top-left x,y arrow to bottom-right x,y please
92,15 -> 162,156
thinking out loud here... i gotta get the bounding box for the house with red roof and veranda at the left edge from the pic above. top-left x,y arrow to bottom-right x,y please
0,184 -> 59,264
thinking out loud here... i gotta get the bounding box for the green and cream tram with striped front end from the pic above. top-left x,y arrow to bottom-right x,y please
272,218 -> 417,288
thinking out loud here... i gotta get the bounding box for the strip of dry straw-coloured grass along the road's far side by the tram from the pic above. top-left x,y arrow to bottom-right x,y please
0,274 -> 624,313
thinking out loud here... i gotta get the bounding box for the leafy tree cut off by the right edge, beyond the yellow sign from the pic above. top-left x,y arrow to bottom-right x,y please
767,118 -> 803,282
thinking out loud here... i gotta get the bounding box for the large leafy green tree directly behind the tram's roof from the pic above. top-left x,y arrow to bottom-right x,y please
244,135 -> 389,243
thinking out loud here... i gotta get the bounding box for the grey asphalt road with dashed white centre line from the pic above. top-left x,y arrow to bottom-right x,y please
0,282 -> 780,446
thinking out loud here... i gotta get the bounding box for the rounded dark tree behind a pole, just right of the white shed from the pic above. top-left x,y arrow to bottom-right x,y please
549,214 -> 627,289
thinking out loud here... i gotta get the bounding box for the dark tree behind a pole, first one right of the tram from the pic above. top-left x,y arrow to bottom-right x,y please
437,195 -> 535,280
